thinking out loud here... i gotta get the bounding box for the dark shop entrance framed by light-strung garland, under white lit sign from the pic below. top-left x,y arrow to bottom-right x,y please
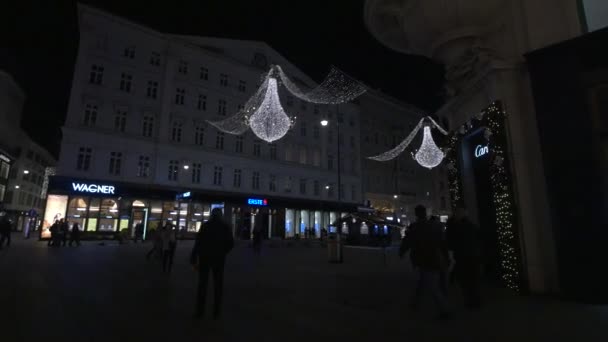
446,101 -> 523,291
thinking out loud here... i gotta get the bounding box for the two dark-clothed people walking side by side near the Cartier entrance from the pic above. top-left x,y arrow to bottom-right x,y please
399,206 -> 482,319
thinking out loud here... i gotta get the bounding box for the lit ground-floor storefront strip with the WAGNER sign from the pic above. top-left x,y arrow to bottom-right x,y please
40,176 -> 356,239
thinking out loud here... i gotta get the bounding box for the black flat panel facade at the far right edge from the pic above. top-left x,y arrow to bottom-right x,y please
526,29 -> 608,303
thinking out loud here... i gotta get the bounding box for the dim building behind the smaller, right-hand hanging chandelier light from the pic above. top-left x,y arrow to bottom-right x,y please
358,90 -> 450,225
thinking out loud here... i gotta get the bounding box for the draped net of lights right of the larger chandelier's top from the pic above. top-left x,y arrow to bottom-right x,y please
274,65 -> 367,104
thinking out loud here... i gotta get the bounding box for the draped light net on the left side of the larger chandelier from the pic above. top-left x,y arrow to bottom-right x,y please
207,70 -> 272,135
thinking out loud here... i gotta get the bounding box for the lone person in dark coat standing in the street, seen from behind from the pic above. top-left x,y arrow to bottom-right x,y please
190,208 -> 234,319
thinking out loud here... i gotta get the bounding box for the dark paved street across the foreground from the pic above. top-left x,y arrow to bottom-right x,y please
0,235 -> 608,342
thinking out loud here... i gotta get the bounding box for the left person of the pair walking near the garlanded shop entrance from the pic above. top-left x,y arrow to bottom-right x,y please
399,205 -> 450,319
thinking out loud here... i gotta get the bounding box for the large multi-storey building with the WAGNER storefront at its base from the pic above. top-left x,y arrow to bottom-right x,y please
43,5 -> 363,237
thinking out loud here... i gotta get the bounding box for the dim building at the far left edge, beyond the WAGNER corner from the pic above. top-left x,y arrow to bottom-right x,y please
0,71 -> 55,234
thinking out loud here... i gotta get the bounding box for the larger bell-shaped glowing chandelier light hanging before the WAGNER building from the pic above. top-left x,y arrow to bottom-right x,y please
249,77 -> 293,143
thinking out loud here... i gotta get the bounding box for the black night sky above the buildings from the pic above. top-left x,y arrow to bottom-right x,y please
0,0 -> 443,153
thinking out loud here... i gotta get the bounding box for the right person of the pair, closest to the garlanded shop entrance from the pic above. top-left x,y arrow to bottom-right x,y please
447,208 -> 482,309
